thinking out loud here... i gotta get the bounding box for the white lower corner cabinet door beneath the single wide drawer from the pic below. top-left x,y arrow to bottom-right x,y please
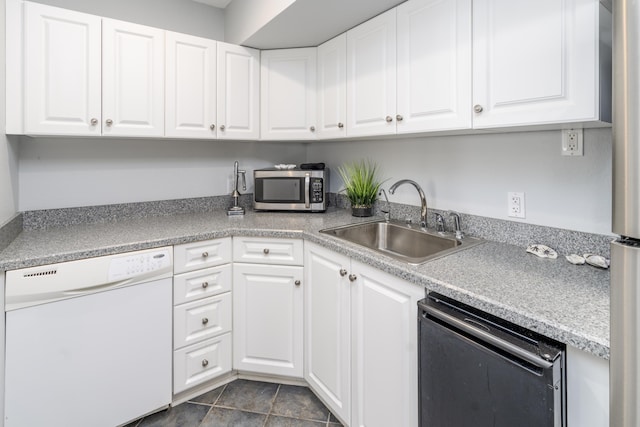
233,263 -> 303,378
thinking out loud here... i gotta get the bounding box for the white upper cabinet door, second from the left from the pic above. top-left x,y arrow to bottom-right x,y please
102,19 -> 164,136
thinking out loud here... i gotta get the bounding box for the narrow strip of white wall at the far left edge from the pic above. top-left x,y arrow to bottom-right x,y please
0,0 -> 18,225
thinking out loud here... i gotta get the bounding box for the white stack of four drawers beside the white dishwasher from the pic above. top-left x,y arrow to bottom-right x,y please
173,237 -> 233,396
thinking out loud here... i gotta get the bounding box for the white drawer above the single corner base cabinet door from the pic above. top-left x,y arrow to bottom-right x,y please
233,237 -> 303,265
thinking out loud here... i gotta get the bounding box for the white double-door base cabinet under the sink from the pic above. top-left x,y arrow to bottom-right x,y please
305,243 -> 424,427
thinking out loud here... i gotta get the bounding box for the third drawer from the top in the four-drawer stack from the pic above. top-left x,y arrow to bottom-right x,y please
173,292 -> 232,349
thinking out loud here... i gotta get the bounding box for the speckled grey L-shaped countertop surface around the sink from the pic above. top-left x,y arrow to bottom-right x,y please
0,209 -> 609,359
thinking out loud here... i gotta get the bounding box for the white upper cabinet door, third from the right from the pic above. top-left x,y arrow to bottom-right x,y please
347,9 -> 396,136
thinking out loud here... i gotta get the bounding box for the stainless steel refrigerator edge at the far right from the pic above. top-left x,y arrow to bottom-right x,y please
609,0 -> 640,427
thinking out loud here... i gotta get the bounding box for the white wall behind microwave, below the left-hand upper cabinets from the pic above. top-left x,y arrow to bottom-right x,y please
19,137 -> 306,211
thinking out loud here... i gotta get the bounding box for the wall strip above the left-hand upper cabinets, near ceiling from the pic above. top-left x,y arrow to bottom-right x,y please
32,0 -> 224,41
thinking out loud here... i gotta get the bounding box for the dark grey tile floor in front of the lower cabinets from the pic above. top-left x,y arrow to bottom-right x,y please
127,380 -> 342,427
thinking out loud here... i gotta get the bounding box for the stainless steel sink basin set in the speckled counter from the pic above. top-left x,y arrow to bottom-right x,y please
320,221 -> 484,264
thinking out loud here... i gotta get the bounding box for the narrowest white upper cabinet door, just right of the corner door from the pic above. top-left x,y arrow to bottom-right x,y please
317,33 -> 347,138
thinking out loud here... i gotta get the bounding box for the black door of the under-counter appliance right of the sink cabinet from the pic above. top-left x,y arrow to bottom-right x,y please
419,298 -> 562,427
